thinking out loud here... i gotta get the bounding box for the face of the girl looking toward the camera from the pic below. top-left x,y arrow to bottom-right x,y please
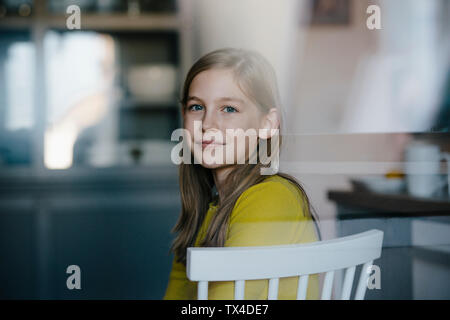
183,69 -> 277,169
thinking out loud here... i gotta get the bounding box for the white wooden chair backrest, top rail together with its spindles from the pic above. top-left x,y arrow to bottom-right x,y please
186,229 -> 383,300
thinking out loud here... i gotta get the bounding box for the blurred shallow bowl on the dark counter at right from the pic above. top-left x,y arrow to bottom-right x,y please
351,176 -> 406,193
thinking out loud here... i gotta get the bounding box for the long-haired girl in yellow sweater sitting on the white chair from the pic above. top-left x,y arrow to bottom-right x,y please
164,48 -> 318,299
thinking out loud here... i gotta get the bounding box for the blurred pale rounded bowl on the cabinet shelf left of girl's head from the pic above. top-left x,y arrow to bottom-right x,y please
128,64 -> 177,102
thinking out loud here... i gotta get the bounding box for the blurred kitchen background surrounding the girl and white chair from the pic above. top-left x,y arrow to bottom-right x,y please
0,0 -> 450,299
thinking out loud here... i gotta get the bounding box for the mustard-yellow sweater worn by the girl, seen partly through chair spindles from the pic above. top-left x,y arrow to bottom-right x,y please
164,175 -> 319,300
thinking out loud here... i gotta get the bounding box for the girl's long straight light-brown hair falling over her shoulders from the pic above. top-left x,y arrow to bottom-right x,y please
171,48 -> 320,264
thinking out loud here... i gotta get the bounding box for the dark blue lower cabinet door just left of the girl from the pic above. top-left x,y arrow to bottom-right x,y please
48,193 -> 179,299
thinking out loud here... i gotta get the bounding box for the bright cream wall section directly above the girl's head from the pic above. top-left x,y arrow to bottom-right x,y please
192,0 -> 306,112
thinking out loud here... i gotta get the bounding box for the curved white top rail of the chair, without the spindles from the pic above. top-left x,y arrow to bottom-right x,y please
186,229 -> 383,281
